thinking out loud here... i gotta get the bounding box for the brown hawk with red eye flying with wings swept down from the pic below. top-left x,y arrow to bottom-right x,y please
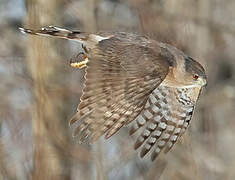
20,26 -> 206,160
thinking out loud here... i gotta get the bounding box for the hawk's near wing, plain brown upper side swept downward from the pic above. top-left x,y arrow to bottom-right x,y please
70,37 -> 169,142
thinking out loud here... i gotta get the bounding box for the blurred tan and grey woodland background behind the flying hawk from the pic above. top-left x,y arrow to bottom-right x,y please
0,0 -> 235,180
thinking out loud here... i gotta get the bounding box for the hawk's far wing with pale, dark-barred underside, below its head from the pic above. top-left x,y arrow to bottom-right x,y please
130,85 -> 201,160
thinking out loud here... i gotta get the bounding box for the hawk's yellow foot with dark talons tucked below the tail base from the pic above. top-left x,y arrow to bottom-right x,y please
70,52 -> 88,69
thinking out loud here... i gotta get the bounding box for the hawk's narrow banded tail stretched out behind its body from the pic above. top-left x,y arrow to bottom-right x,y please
19,26 -> 89,43
